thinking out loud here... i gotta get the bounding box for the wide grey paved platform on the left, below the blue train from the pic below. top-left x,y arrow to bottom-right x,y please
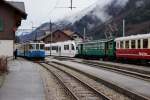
0,60 -> 45,100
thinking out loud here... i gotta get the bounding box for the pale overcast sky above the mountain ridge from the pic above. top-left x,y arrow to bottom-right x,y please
7,0 -> 97,29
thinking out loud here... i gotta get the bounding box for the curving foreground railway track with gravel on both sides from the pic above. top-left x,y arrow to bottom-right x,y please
40,63 -> 111,100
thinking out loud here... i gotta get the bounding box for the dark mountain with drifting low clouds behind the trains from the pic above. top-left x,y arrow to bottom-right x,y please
19,0 -> 150,39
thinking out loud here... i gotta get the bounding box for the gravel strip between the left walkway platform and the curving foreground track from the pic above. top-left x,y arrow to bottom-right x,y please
39,64 -> 72,100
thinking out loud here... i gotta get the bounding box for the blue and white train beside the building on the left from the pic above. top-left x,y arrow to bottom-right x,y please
16,42 -> 45,59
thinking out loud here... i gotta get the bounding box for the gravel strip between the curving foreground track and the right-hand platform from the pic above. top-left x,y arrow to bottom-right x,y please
49,62 -> 131,100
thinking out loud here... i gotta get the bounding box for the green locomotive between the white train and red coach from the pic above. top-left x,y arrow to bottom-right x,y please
78,39 -> 115,59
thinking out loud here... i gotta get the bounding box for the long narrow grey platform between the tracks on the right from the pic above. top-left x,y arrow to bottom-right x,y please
55,60 -> 150,98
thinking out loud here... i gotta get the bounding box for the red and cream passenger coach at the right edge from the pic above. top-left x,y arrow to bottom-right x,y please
115,34 -> 150,61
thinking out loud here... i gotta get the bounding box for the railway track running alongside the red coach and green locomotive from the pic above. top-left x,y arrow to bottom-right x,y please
50,58 -> 150,81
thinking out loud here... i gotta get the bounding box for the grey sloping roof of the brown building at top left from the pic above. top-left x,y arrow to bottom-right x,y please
2,0 -> 27,19
